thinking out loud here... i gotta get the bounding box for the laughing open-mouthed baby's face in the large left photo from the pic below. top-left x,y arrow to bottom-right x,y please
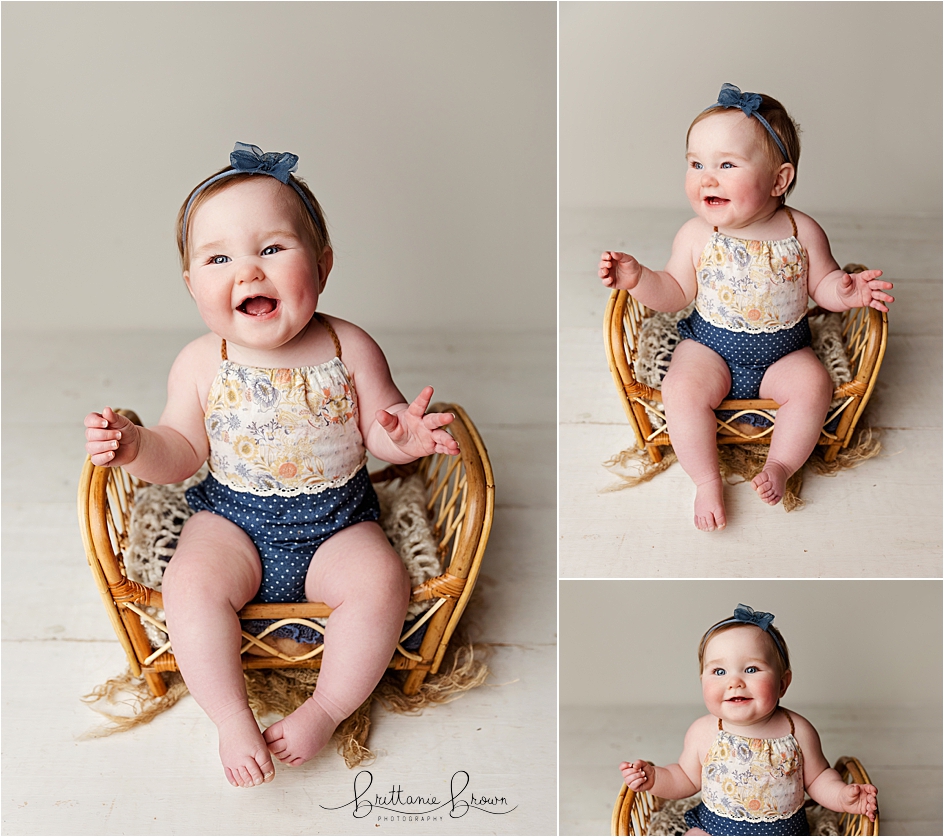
184,175 -> 330,350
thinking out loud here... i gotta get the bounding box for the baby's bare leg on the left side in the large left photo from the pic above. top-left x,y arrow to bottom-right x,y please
163,511 -> 275,787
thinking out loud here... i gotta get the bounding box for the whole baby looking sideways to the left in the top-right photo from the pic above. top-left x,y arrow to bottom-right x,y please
599,84 -> 894,531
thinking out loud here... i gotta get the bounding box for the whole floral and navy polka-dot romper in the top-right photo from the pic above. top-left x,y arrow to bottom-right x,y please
678,207 -> 811,426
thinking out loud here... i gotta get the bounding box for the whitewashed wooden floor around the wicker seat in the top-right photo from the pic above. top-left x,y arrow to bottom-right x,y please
558,209 -> 942,578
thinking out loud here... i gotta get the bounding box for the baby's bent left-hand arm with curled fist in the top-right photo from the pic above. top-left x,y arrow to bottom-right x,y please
598,219 -> 697,311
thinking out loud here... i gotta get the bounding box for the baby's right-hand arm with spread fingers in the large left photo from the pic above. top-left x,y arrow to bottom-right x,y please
331,318 -> 459,465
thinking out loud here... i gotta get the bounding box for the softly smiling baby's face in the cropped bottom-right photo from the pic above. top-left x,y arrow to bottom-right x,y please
701,625 -> 791,727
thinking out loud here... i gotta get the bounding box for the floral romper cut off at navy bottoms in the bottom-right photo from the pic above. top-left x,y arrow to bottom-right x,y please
685,709 -> 810,835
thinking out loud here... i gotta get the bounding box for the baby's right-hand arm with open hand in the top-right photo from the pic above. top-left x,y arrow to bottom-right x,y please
795,212 -> 895,311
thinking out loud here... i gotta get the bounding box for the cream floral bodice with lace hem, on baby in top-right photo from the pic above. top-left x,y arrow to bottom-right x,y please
695,207 -> 809,334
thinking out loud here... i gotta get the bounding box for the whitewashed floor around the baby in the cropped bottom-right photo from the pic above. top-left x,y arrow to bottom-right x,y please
560,703 -> 944,835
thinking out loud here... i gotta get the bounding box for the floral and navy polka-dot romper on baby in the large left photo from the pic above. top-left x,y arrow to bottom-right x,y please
187,314 -> 380,602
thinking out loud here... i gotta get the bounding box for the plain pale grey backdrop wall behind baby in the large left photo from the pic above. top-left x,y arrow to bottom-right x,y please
2,2 -> 556,331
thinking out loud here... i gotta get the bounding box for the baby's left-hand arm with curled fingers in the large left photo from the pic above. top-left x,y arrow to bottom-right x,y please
85,341 -> 209,485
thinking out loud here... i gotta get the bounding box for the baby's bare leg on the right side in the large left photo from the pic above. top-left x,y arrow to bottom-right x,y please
265,522 -> 410,766
